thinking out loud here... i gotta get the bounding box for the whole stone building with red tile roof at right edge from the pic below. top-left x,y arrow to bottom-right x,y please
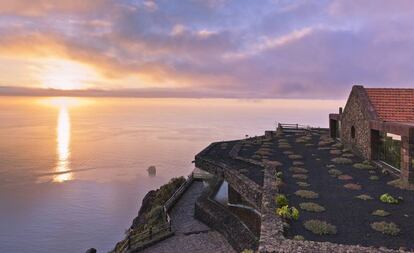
329,85 -> 414,184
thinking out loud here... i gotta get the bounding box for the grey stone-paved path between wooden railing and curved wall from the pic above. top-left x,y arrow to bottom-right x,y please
142,181 -> 235,253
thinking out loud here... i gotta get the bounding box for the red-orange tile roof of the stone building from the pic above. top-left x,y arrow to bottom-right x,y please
365,88 -> 414,122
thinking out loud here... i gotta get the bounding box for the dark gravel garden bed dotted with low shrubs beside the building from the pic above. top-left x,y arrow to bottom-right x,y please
239,130 -> 414,250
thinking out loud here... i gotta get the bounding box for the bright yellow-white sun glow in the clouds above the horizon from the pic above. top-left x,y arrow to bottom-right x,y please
39,58 -> 99,90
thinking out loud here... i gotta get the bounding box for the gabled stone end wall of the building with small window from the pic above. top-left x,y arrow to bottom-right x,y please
341,86 -> 372,159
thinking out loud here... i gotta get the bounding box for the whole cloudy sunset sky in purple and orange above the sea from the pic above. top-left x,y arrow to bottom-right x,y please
0,0 -> 414,98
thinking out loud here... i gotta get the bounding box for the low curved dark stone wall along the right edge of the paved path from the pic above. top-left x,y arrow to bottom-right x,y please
194,179 -> 258,252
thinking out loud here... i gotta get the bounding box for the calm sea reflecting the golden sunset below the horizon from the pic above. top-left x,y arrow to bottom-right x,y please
0,97 -> 344,253
